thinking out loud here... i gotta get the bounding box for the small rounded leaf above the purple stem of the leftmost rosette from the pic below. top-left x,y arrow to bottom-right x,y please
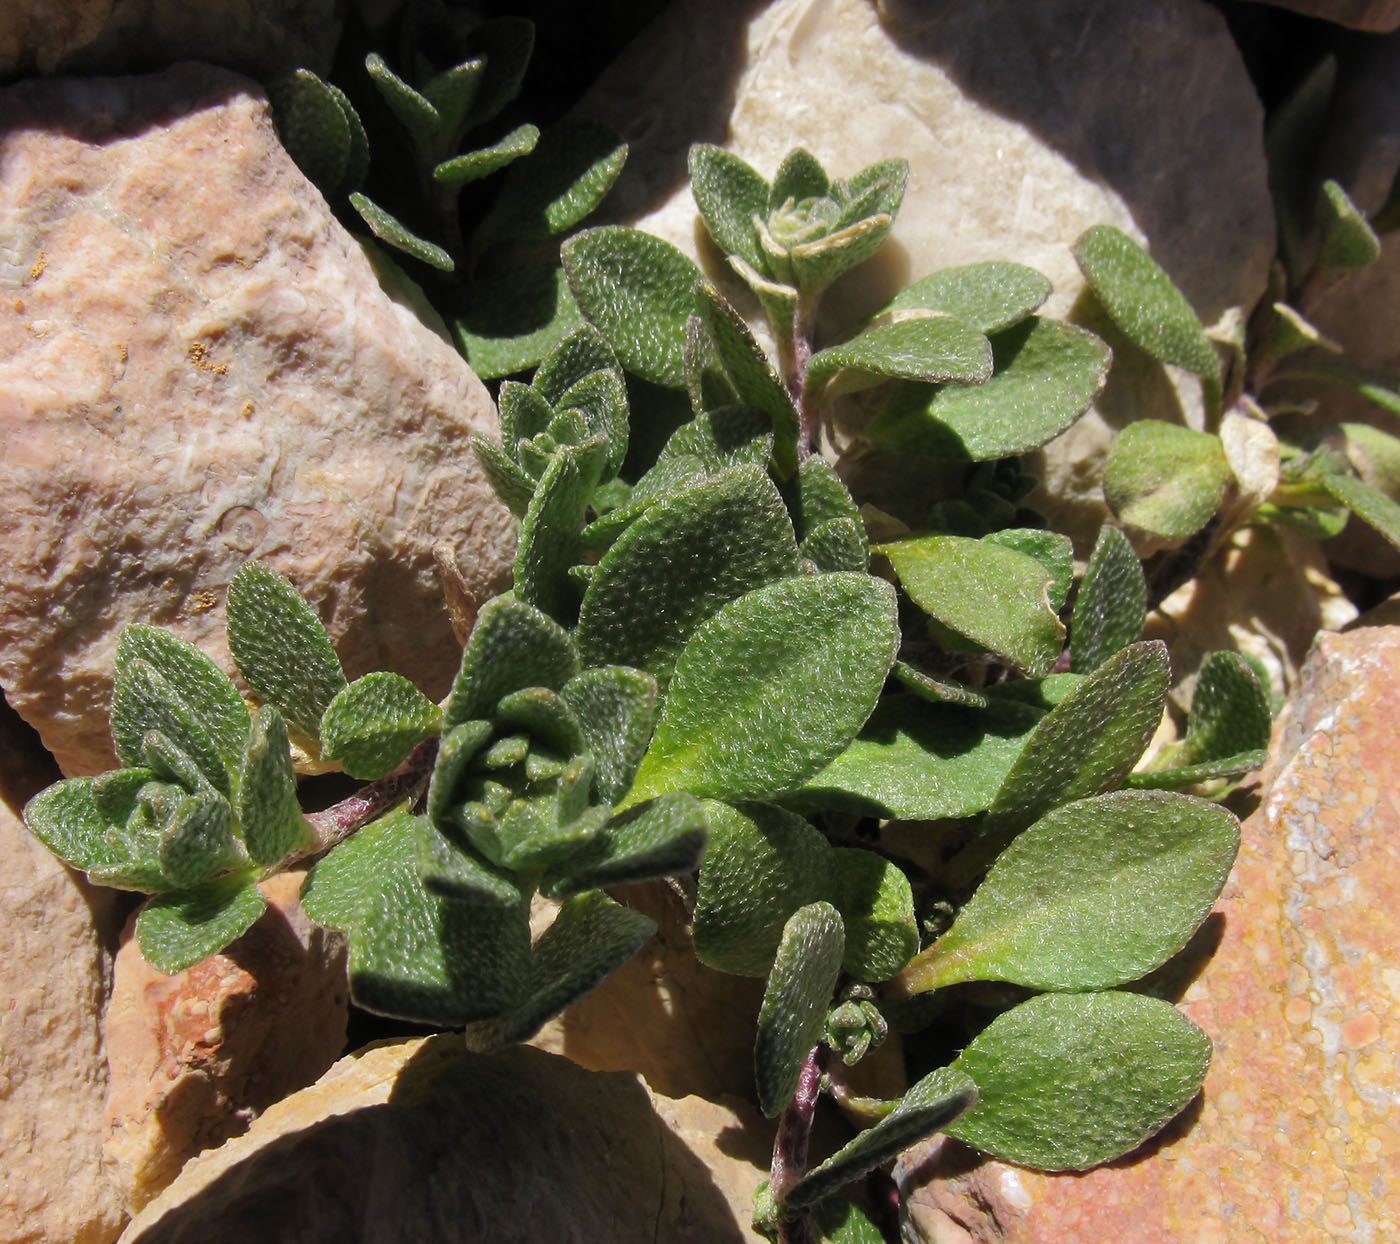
321,670 -> 442,782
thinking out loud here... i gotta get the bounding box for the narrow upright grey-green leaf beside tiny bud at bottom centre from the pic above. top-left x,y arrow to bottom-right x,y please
753,903 -> 846,1118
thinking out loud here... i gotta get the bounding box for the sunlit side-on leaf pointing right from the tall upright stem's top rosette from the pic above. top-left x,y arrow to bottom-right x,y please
805,313 -> 991,393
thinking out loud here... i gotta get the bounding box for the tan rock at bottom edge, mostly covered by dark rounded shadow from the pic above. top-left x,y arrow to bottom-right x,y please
122,1036 -> 771,1244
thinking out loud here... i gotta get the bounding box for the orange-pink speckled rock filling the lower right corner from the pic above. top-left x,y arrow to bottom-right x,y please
896,627 -> 1400,1244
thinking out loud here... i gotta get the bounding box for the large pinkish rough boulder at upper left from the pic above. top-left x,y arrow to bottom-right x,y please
0,64 -> 512,774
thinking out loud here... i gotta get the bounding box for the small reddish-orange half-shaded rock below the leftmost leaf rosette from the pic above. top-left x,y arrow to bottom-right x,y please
105,872 -> 349,1210
